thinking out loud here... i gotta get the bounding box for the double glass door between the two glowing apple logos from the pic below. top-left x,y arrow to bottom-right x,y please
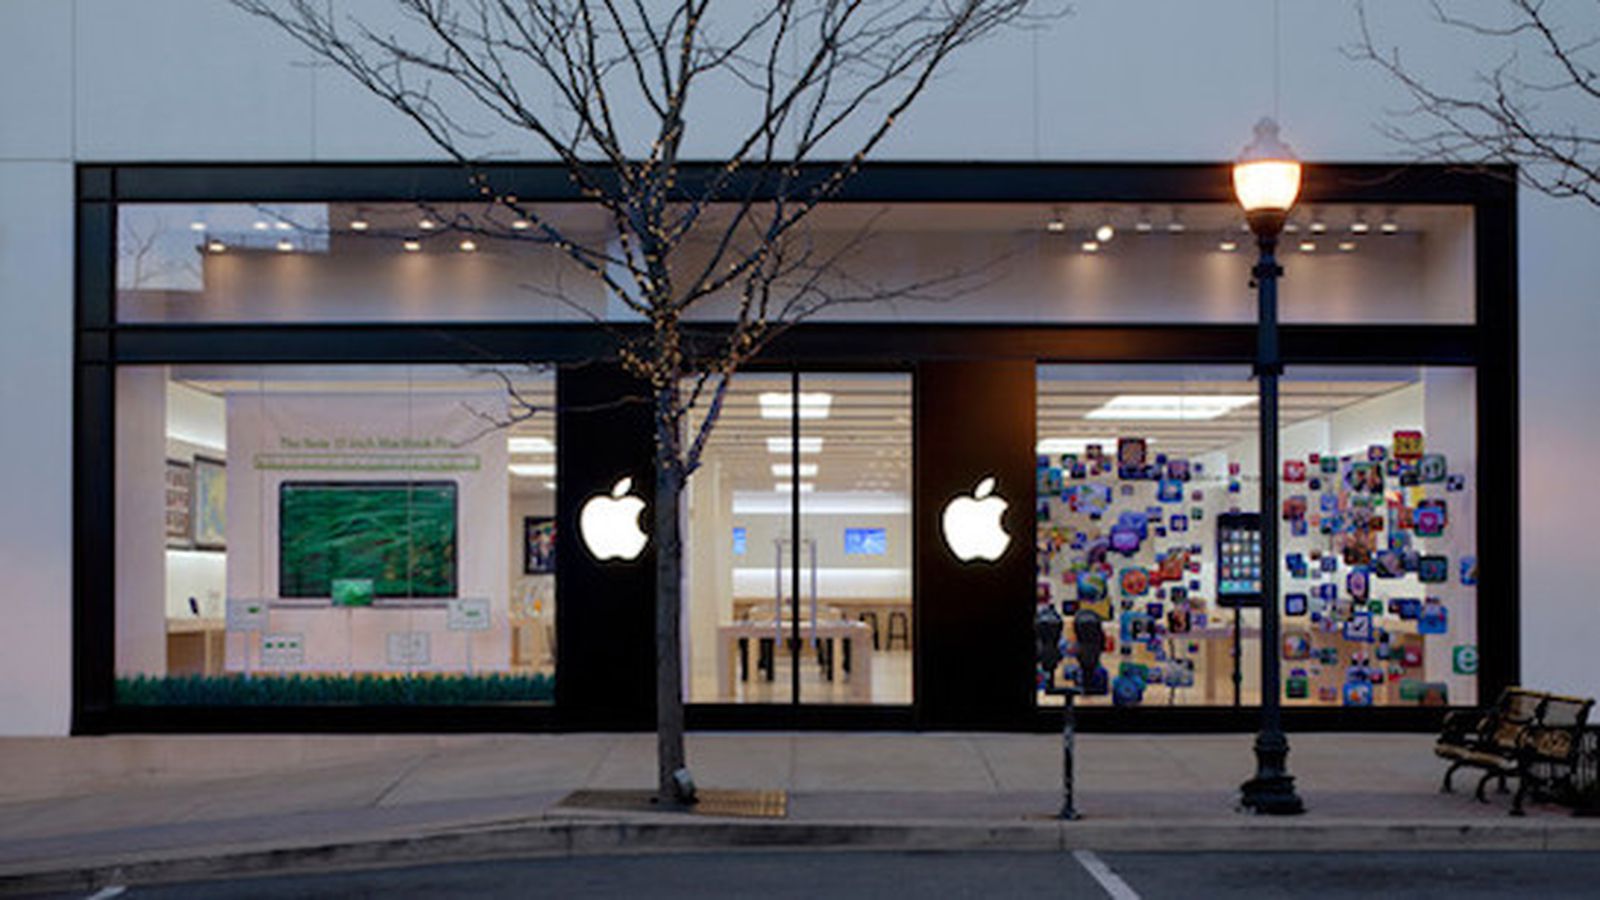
683,372 -> 914,705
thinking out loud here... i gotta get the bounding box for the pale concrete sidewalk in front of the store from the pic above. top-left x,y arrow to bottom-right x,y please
0,733 -> 1600,892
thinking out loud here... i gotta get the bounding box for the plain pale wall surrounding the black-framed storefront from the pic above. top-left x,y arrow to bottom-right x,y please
0,0 -> 1600,733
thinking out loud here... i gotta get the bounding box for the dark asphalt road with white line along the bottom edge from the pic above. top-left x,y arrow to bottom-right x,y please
50,852 -> 1600,900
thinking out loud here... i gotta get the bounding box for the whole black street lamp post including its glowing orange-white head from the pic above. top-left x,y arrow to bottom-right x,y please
1234,119 -> 1306,815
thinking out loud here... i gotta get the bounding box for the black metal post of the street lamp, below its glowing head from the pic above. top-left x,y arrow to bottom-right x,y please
1235,219 -> 1306,815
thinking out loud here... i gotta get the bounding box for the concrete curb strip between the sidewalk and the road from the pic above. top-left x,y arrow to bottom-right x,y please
0,815 -> 1600,895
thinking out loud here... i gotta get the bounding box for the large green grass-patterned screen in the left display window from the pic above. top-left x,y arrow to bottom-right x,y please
278,482 -> 456,597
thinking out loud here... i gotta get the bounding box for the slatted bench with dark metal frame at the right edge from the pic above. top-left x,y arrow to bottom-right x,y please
1434,687 -> 1594,815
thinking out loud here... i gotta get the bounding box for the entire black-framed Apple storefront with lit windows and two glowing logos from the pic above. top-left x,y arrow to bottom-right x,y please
74,163 -> 1518,733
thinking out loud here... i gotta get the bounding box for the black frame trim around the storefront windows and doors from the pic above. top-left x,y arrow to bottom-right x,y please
72,162 -> 1520,733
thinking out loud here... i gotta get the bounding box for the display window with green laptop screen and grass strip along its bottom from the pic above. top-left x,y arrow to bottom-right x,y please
115,365 -> 557,706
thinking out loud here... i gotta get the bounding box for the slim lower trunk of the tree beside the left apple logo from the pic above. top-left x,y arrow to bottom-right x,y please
656,445 -> 694,806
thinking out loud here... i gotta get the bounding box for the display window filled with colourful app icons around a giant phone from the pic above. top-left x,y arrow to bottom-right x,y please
1035,365 -> 1478,706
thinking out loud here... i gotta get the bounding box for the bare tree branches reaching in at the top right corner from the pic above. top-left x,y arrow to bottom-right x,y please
1347,0 -> 1600,207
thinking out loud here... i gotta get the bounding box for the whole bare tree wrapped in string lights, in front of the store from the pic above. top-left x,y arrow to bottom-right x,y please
234,0 -> 1058,804
